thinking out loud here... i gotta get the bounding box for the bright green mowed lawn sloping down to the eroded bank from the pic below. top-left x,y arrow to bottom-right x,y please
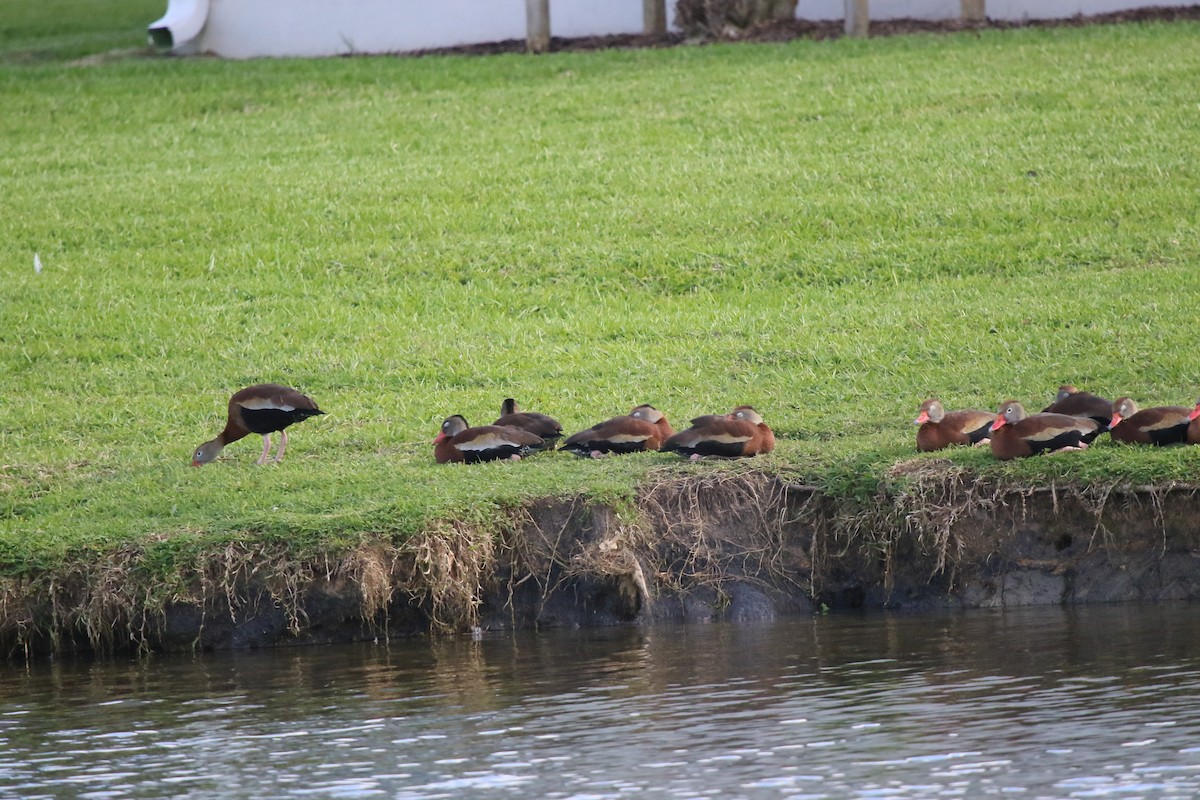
0,7 -> 1200,577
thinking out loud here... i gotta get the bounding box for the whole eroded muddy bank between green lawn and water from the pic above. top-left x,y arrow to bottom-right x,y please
0,470 -> 1200,656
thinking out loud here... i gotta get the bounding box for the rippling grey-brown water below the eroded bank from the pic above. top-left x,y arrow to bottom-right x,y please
0,606 -> 1200,800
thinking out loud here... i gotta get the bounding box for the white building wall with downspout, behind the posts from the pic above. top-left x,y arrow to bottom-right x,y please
150,0 -> 1195,59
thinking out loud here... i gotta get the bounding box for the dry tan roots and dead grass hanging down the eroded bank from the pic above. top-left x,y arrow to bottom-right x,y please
7,470 -> 1200,655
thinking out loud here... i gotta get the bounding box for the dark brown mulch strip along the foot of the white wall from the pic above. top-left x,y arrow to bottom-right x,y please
403,5 -> 1200,56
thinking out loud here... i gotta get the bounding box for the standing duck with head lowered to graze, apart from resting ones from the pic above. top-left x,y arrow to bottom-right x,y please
192,384 -> 324,467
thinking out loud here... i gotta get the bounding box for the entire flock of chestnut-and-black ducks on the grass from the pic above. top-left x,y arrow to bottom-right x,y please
184,384 -> 1200,467
